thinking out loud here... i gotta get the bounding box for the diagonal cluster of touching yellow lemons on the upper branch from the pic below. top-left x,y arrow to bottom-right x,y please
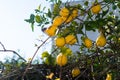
45,7 -> 78,36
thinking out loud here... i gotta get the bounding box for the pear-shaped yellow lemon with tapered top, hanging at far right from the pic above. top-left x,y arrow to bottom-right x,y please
96,33 -> 106,47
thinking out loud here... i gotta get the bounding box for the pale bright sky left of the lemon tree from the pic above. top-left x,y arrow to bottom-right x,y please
0,0 -> 51,60
